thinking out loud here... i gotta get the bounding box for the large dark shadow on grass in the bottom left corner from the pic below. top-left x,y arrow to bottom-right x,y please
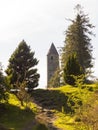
0,104 -> 35,130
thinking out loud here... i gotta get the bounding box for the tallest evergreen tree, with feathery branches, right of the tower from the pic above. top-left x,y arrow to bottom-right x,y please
61,5 -> 94,73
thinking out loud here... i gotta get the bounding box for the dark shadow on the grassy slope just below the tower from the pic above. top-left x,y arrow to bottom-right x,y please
32,89 -> 72,113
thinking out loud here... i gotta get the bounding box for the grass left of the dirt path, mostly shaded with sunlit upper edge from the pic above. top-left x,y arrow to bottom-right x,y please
0,94 -> 36,130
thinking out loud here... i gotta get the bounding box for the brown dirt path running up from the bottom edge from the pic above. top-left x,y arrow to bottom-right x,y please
22,106 -> 60,130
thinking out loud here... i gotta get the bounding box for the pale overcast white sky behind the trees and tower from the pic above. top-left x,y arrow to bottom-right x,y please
0,0 -> 98,87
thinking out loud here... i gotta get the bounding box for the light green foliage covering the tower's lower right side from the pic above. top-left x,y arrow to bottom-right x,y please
48,69 -> 60,88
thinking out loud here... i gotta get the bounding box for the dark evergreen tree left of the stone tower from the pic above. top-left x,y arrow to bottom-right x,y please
6,40 -> 39,90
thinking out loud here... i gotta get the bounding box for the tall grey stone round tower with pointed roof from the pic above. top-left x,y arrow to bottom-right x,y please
47,43 -> 59,86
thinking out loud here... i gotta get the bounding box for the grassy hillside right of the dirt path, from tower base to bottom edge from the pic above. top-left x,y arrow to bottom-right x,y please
32,84 -> 98,130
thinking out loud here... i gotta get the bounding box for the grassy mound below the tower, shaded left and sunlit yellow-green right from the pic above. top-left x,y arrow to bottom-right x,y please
32,85 -> 95,113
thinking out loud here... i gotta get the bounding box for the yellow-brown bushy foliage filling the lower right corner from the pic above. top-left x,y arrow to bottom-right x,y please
75,91 -> 98,130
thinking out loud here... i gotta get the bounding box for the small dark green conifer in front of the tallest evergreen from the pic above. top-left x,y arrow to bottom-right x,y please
64,54 -> 83,85
